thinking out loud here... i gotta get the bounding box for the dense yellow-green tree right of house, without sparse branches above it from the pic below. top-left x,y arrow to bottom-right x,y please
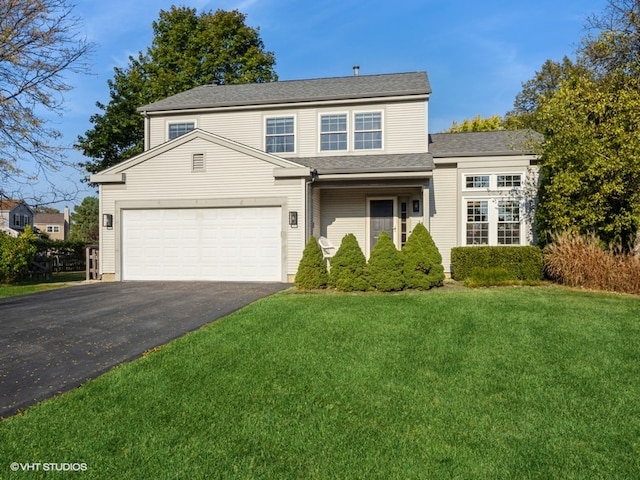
537,71 -> 640,248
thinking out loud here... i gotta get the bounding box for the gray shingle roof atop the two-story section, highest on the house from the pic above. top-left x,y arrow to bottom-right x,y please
138,72 -> 431,112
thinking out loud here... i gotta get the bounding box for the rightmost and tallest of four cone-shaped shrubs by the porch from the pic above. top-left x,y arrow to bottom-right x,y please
402,223 -> 444,290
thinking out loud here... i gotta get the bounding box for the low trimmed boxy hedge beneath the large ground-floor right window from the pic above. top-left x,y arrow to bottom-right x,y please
451,246 -> 544,281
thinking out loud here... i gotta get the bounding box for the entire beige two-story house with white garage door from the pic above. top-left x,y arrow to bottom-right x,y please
91,72 -> 536,281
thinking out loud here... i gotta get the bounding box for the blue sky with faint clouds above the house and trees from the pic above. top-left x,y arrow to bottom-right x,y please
27,0 -> 607,208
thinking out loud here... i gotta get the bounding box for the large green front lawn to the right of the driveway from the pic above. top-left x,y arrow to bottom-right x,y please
0,287 -> 640,479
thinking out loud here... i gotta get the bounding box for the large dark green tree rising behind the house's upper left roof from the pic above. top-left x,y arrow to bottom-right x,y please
76,7 -> 277,173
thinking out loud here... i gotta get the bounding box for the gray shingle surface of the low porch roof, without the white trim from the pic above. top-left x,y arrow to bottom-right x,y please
291,153 -> 434,174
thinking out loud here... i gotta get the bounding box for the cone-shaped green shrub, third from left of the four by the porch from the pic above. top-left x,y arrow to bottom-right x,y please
367,232 -> 404,292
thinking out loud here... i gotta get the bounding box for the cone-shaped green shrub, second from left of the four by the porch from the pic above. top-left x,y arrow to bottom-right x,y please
329,233 -> 369,292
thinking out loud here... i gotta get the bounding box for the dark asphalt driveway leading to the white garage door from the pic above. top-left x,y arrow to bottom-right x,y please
0,282 -> 289,418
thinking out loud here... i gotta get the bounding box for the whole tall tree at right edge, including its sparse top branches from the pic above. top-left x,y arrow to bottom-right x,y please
533,0 -> 640,249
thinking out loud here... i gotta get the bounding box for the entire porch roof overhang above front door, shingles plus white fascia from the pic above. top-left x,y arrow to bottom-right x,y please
295,153 -> 434,181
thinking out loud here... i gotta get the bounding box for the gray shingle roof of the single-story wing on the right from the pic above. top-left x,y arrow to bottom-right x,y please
429,130 -> 542,158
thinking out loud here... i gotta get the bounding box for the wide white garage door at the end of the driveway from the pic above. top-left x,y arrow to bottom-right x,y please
122,207 -> 282,281
